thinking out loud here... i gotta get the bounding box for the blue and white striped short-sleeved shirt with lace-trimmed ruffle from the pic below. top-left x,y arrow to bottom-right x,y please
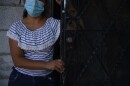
7,17 -> 60,76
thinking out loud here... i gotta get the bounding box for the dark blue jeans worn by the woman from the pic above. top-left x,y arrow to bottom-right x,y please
8,69 -> 55,86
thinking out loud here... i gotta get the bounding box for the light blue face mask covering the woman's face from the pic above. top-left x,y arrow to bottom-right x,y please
24,0 -> 44,17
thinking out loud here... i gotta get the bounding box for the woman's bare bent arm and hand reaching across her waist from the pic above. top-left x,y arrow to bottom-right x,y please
9,38 -> 64,72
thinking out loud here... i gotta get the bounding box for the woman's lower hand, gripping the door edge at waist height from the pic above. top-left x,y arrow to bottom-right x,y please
47,59 -> 65,73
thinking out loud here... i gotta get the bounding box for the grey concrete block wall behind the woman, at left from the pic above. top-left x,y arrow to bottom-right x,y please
0,0 -> 23,86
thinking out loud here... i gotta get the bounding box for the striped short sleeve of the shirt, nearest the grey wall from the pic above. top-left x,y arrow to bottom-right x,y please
7,23 -> 18,41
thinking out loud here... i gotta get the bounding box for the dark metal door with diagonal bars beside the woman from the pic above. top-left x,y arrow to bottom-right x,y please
52,0 -> 130,86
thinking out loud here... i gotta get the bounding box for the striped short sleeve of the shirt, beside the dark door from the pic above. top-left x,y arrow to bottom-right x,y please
51,18 -> 61,41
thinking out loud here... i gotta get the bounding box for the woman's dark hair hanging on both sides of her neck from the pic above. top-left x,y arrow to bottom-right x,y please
23,0 -> 50,18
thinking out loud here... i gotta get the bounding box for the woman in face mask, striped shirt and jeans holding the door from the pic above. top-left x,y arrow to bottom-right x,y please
7,0 -> 64,86
